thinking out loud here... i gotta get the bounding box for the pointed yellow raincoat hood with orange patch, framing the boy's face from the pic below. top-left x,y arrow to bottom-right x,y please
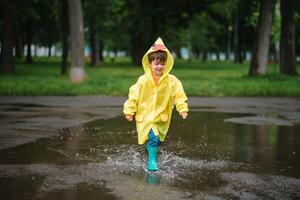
142,37 -> 174,79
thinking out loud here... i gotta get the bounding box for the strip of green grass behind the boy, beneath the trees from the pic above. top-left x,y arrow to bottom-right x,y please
0,58 -> 300,96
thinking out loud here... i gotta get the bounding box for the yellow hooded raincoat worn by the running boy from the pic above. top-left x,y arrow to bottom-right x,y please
123,38 -> 189,144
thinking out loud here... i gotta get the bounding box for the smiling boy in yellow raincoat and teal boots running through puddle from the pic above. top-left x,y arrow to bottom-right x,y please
123,38 -> 189,171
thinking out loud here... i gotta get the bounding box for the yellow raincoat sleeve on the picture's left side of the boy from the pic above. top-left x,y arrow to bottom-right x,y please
123,78 -> 141,115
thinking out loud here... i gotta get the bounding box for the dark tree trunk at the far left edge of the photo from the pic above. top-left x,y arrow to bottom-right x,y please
1,1 -> 15,74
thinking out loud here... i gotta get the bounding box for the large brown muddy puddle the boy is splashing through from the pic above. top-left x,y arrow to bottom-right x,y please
0,112 -> 300,199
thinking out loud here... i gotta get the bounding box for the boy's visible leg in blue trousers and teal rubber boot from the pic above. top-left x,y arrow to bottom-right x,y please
146,129 -> 161,171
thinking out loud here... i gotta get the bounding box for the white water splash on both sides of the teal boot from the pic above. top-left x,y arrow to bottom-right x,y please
98,145 -> 232,181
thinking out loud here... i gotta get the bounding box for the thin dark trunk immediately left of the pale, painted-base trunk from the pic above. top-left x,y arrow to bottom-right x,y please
60,0 -> 69,75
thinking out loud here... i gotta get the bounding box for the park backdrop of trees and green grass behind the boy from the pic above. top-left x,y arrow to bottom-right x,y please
0,0 -> 300,96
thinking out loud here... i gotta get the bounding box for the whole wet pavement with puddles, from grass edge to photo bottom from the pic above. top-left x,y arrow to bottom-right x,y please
0,96 -> 300,199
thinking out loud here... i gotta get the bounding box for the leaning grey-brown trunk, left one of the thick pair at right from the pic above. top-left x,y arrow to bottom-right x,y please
249,0 -> 276,75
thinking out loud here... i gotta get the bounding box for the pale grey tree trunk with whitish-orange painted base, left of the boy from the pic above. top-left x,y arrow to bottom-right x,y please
68,0 -> 85,83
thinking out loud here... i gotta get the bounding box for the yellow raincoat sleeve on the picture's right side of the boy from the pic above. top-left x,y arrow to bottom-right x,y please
173,77 -> 189,113
